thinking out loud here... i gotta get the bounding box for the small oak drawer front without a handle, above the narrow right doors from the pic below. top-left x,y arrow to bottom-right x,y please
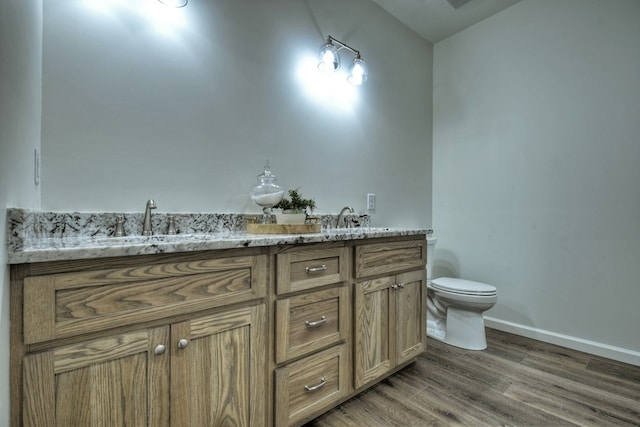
355,237 -> 427,278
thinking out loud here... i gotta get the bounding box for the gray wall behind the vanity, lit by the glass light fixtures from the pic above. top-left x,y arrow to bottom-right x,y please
42,0 -> 432,226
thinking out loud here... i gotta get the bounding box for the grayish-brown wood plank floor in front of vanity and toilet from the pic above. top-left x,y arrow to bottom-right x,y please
306,329 -> 640,427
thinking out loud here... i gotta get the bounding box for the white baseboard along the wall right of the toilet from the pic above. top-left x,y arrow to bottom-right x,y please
484,316 -> 640,366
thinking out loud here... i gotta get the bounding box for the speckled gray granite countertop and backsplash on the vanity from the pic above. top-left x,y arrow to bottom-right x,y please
7,208 -> 427,264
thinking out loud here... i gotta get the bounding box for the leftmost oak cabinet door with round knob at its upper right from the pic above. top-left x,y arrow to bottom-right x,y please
23,327 -> 170,427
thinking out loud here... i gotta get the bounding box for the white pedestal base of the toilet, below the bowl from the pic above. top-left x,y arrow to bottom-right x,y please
432,306 -> 487,350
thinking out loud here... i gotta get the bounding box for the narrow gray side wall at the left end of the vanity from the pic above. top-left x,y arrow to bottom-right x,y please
0,0 -> 42,426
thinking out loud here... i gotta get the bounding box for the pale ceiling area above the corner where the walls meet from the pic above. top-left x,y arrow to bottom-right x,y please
373,0 -> 520,43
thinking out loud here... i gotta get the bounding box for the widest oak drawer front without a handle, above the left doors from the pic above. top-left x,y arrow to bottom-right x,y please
23,254 -> 267,344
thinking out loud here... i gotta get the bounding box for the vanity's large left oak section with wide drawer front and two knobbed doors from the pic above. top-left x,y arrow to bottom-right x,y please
12,250 -> 267,426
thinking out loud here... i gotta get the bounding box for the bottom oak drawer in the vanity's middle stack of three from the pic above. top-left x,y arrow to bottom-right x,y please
275,344 -> 349,426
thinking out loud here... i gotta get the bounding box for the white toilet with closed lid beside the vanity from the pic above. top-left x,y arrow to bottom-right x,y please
427,237 -> 498,350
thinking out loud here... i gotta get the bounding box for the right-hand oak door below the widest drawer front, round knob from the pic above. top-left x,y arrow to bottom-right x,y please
171,305 -> 267,427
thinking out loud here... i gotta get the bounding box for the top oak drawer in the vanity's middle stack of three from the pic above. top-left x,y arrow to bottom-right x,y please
276,245 -> 349,294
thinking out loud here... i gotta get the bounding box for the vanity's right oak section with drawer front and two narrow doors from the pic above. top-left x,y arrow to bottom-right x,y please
354,240 -> 426,388
